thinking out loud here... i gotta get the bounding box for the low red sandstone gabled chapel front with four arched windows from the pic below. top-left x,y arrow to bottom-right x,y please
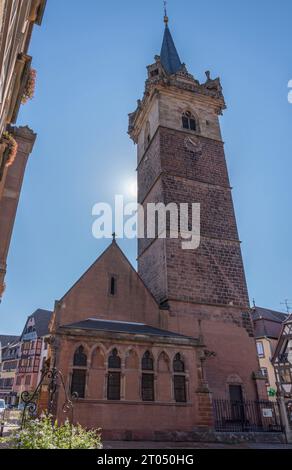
51,242 -> 213,439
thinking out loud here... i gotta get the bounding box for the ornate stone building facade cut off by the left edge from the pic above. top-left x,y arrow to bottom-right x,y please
0,0 -> 46,299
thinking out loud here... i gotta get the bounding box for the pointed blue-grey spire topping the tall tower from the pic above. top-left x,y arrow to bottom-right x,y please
160,1 -> 182,75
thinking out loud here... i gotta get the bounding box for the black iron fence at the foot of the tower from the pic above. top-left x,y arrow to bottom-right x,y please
213,399 -> 283,432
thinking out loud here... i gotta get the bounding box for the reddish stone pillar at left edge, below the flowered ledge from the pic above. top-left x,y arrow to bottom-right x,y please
0,127 -> 36,298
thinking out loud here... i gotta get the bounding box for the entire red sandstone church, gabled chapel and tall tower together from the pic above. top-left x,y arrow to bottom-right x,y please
50,20 -> 266,440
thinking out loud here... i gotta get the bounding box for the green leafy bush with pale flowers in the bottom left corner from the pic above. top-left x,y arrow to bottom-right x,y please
10,414 -> 102,449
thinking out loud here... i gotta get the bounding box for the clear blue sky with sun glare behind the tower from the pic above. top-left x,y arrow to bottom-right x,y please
0,0 -> 292,334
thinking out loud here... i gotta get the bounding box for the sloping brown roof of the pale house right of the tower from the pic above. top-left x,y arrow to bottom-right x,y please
251,306 -> 288,339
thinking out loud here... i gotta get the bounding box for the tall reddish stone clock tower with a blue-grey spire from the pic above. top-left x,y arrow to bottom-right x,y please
129,16 -> 265,399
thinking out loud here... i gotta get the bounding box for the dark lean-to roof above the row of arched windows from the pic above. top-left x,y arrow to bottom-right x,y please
60,318 -> 194,340
